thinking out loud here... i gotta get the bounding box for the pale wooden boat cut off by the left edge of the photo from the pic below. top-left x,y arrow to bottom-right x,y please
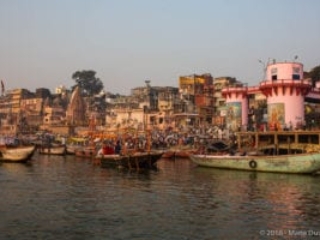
0,146 -> 36,163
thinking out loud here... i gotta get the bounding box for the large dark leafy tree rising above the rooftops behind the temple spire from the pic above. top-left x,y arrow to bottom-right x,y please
72,70 -> 103,96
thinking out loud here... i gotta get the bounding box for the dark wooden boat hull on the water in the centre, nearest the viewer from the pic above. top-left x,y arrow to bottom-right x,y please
95,151 -> 163,169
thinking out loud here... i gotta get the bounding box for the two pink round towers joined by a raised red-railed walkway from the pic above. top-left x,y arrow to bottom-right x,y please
222,62 -> 312,130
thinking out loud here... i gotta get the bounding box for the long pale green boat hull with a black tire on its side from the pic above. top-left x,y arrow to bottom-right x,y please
190,152 -> 320,173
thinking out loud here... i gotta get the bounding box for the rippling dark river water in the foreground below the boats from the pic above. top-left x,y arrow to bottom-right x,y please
0,154 -> 320,240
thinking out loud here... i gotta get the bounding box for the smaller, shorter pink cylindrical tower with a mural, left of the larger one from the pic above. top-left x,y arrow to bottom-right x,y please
222,87 -> 248,131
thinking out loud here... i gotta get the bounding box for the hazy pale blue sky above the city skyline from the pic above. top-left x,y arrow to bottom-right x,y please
0,0 -> 320,94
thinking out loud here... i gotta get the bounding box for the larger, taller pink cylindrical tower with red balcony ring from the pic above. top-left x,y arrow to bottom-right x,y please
259,62 -> 312,130
